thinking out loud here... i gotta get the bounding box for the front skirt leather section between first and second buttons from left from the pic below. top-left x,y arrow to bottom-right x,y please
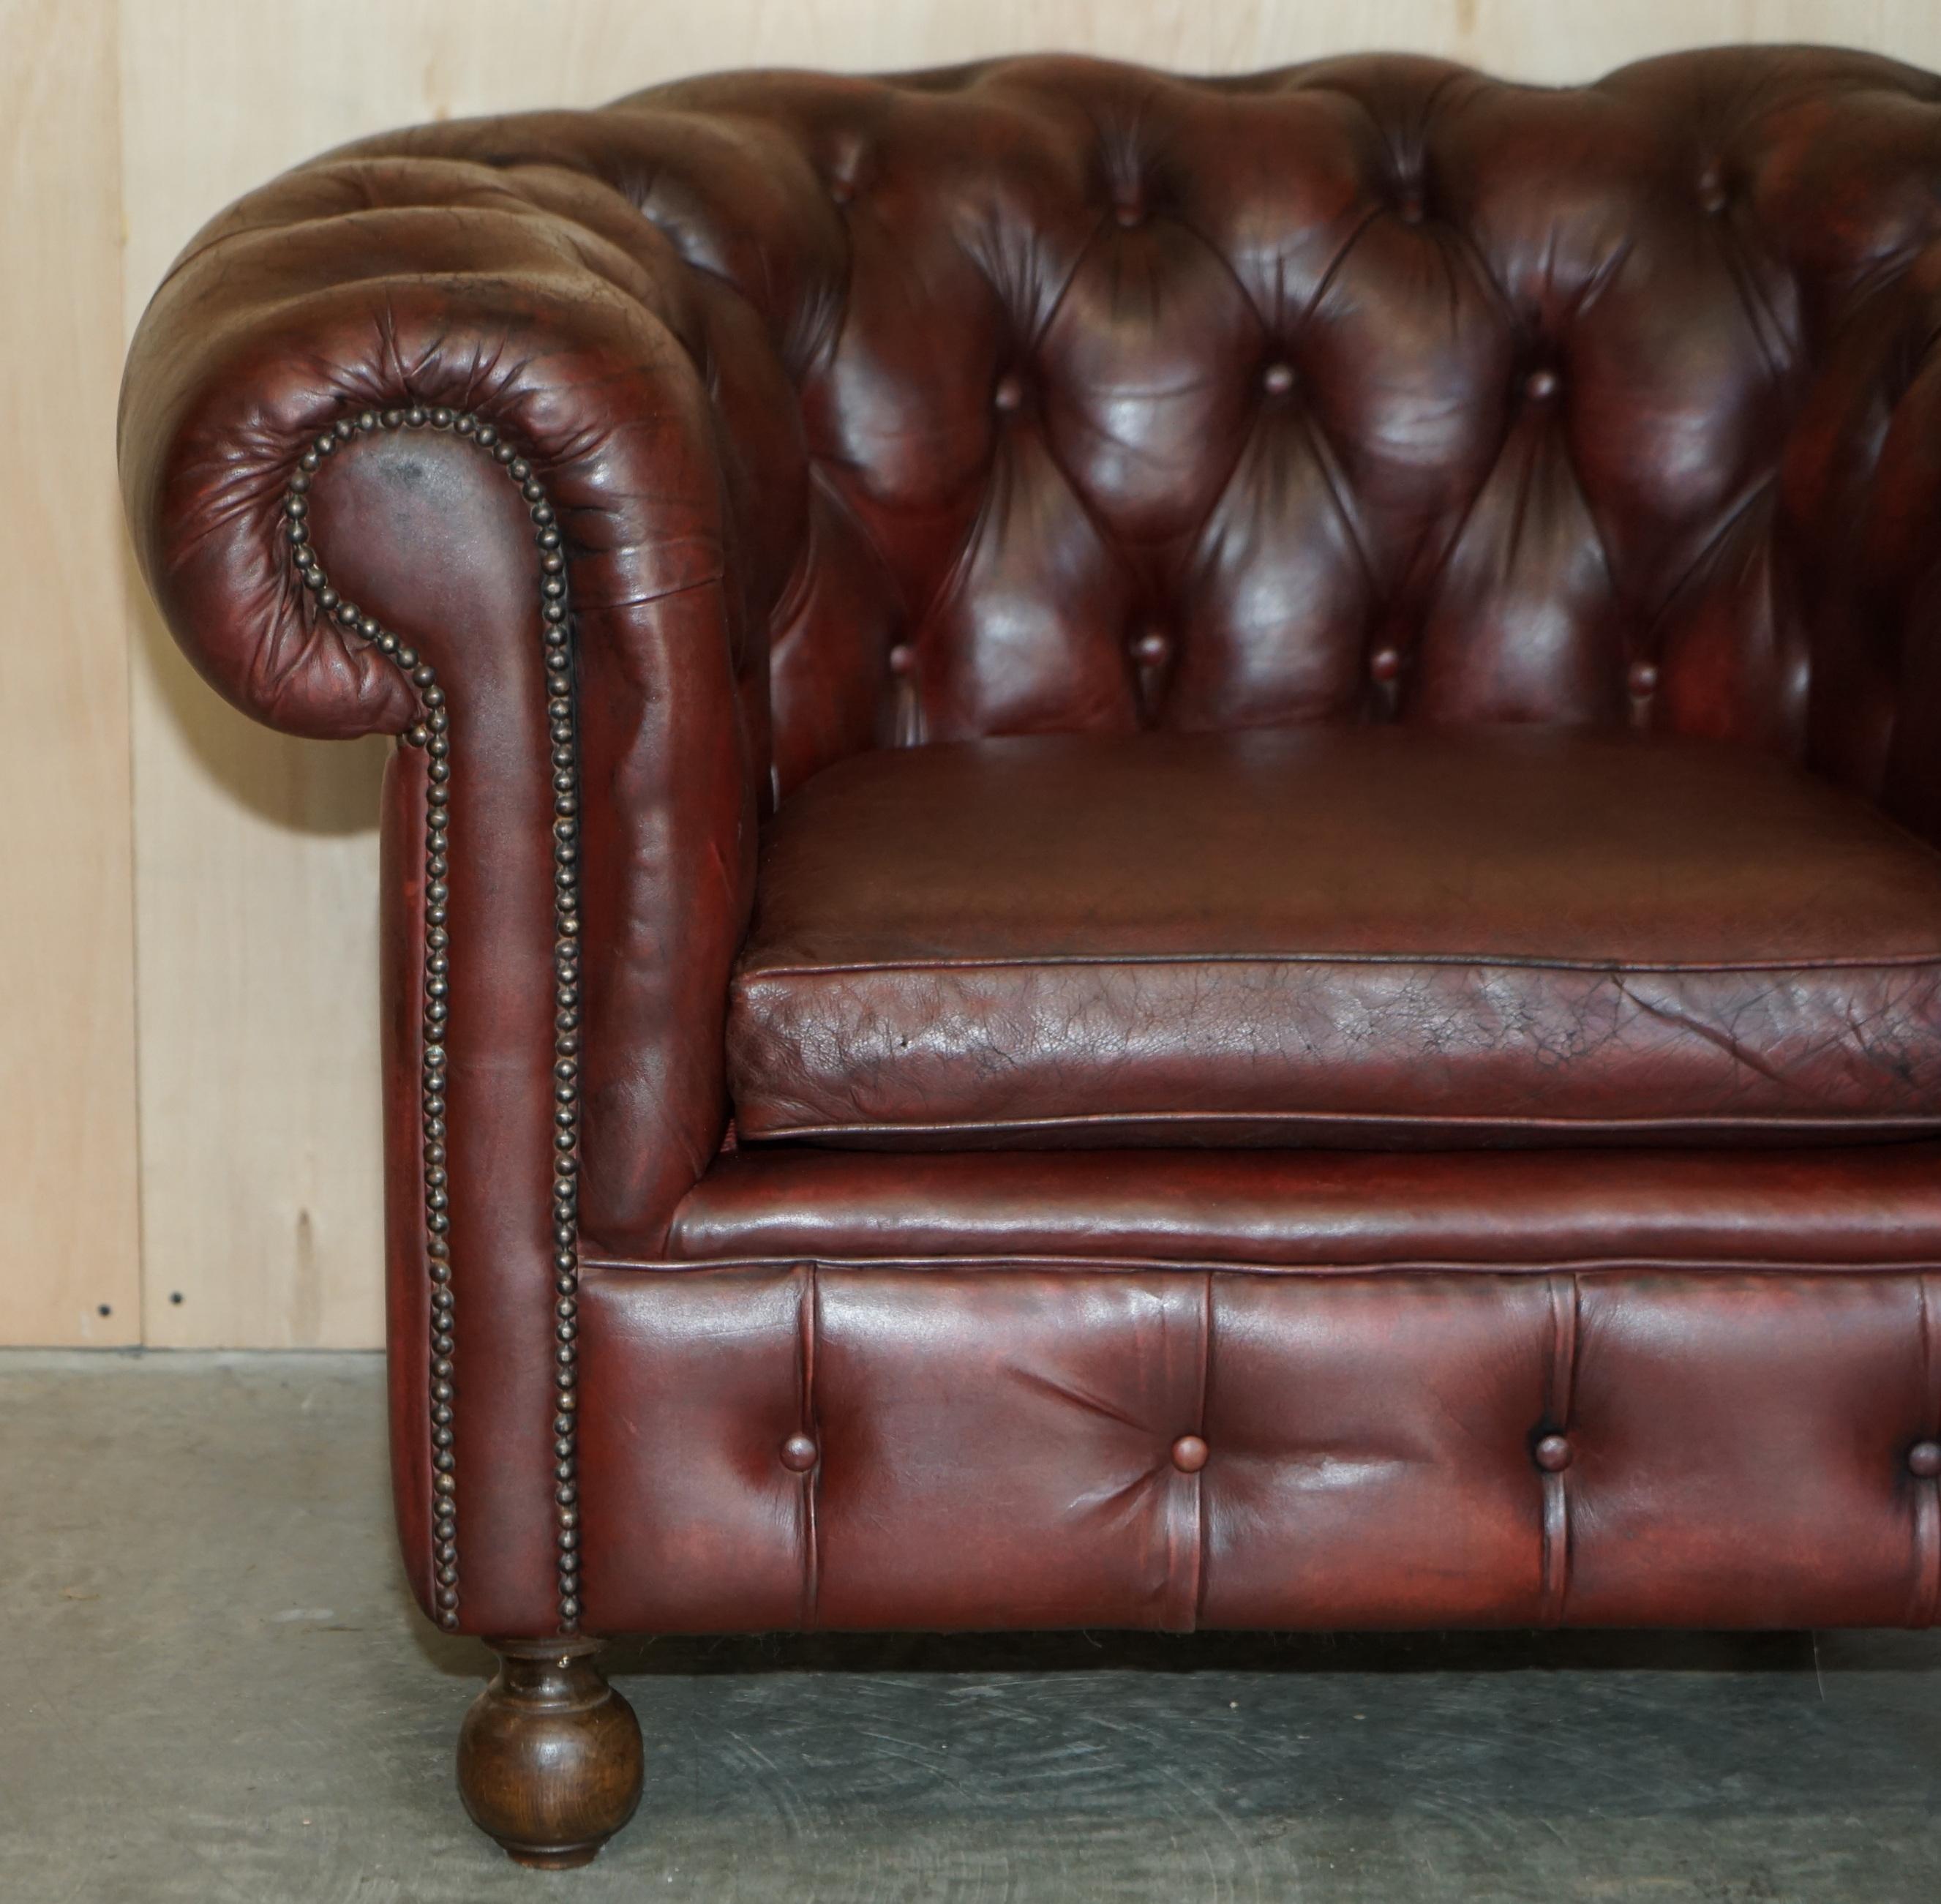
811,1270 -> 1206,1628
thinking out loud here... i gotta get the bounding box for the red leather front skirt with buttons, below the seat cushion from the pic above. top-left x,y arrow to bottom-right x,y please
580,1259 -> 1941,1633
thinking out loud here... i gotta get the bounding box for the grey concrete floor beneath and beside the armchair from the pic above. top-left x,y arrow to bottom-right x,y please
0,1353 -> 1941,1904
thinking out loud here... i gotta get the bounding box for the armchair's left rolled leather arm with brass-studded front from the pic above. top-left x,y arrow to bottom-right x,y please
120,154 -> 806,1634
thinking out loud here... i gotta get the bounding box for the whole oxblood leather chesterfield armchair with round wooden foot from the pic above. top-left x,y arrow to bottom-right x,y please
122,50 -> 1941,1863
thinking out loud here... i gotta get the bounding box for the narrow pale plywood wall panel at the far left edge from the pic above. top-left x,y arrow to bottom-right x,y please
0,0 -> 140,1343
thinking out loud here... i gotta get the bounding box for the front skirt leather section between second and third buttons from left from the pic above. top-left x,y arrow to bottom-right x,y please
1201,1275 -> 1553,1628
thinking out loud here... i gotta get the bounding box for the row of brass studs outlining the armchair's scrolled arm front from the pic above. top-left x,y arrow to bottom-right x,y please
283,404 -> 580,1633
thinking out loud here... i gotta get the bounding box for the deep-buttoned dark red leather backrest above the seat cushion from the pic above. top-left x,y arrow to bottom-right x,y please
295,48 -> 1941,803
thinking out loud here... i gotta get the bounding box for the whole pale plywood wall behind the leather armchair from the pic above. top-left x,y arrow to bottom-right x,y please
11,0 -> 1941,1347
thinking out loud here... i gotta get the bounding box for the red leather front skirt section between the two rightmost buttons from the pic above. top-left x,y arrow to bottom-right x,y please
1569,1275 -> 1941,1627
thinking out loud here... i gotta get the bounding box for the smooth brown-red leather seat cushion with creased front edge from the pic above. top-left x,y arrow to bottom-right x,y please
728,726 -> 1941,1149
